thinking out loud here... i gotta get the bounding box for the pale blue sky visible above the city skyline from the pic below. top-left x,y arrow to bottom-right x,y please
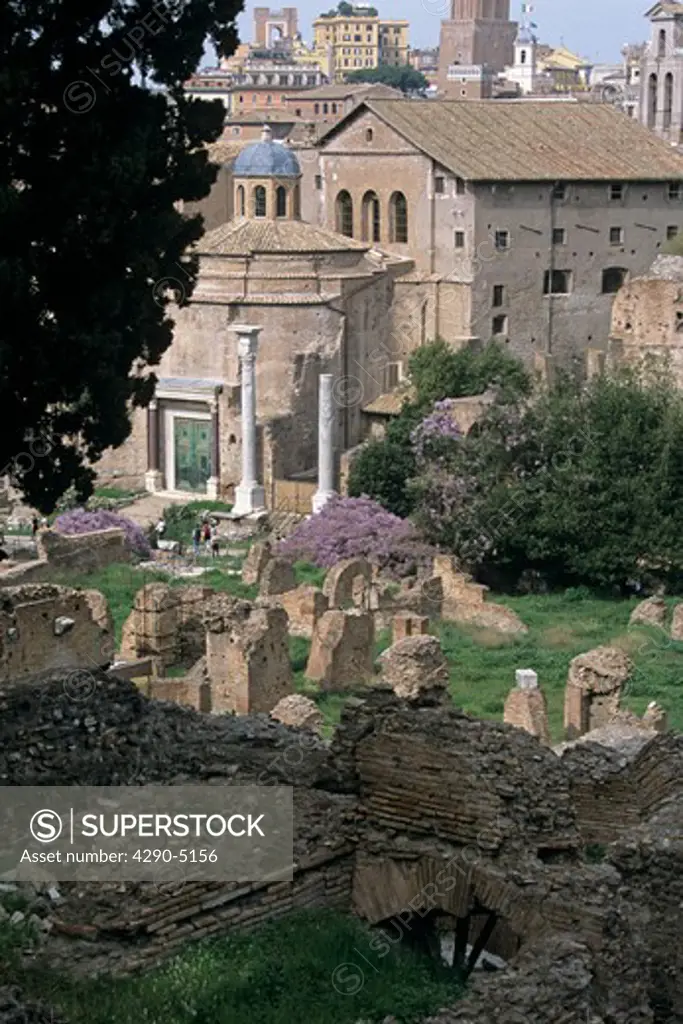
231,0 -> 654,61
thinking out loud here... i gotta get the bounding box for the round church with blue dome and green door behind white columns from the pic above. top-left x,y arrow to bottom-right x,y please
97,128 -> 413,504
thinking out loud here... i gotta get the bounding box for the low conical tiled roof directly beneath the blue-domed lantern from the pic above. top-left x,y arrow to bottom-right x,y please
197,218 -> 369,256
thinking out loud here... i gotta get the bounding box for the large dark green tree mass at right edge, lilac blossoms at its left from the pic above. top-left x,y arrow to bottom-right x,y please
412,371 -> 683,588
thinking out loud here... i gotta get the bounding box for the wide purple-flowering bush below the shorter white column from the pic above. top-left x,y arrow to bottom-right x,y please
278,498 -> 433,575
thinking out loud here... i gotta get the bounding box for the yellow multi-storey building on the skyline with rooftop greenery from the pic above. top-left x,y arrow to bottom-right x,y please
313,7 -> 410,82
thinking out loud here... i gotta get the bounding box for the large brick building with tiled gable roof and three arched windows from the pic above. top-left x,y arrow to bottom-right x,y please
303,100 -> 683,365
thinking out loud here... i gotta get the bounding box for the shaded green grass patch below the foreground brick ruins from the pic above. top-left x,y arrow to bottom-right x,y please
14,910 -> 462,1024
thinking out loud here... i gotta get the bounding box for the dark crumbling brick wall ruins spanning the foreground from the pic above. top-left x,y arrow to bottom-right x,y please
0,667 -> 683,1024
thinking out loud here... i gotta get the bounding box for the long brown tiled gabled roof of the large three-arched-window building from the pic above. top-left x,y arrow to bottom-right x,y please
322,99 -> 683,181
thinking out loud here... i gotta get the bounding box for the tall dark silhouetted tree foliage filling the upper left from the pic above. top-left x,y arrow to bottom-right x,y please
0,0 -> 242,511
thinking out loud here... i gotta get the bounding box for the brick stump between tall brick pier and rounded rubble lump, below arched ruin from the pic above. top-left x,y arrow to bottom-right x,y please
306,608 -> 375,691
